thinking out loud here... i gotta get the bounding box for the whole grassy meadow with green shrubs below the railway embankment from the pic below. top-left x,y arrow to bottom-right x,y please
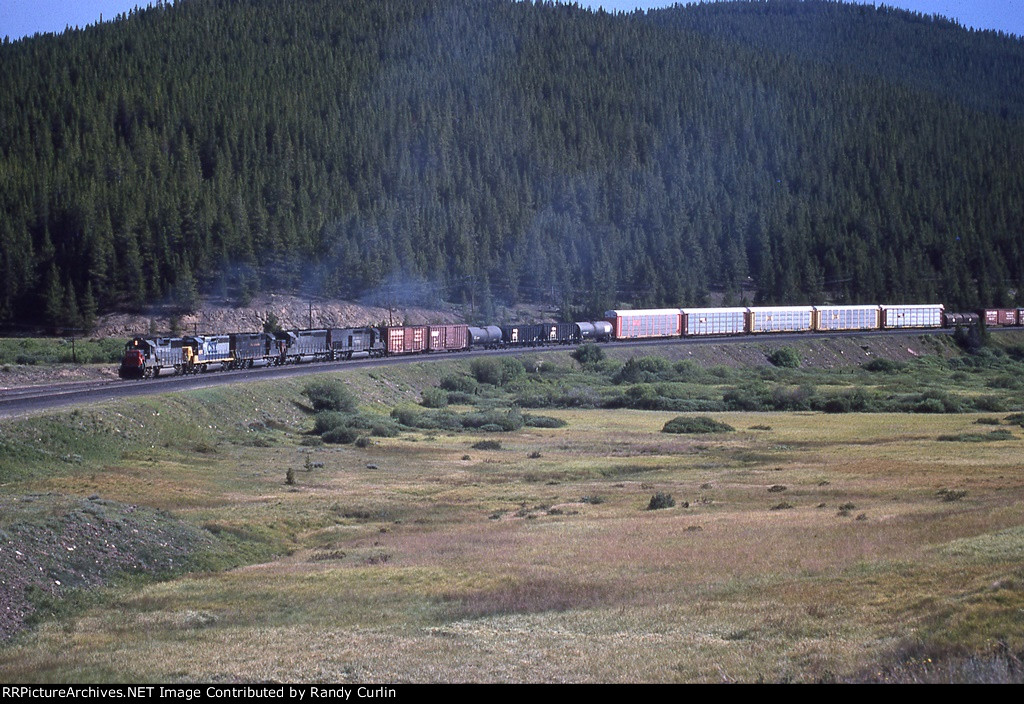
0,335 -> 1024,683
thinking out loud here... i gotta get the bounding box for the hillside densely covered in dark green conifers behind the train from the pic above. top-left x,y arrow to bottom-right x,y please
0,0 -> 1024,325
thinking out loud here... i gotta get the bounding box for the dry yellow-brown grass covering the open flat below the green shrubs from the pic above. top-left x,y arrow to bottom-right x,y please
0,372 -> 1024,681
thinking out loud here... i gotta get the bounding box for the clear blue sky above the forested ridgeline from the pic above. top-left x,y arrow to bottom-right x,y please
0,0 -> 1024,39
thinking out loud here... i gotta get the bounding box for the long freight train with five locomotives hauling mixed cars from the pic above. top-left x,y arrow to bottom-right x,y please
119,304 -> 1024,379
